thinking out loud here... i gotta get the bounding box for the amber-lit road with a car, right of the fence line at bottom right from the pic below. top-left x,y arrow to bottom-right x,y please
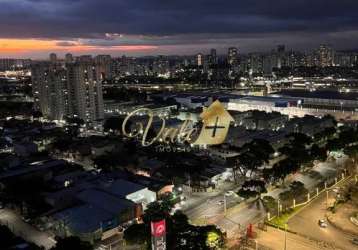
288,179 -> 358,250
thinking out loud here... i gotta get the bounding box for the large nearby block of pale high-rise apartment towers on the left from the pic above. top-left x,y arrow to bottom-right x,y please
31,56 -> 104,124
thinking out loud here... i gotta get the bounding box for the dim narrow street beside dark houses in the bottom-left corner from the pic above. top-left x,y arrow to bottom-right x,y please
0,208 -> 56,249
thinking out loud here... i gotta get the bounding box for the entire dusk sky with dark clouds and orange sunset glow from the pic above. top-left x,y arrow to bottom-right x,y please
0,0 -> 358,59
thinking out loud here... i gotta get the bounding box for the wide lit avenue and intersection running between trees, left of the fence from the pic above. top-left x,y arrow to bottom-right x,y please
182,157 -> 347,240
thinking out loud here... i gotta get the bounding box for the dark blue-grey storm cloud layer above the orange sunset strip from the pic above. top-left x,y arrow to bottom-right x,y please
0,0 -> 358,51
